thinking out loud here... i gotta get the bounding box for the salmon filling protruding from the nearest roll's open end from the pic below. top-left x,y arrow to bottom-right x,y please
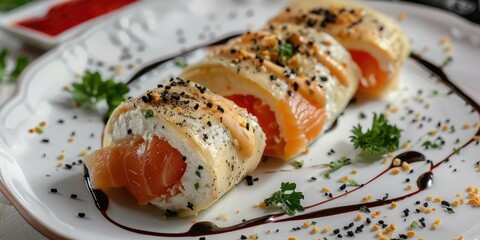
87,137 -> 187,205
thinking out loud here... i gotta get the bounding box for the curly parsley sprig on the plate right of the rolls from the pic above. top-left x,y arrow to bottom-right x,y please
350,113 -> 402,155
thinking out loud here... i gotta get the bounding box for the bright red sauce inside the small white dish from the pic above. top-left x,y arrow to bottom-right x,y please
16,0 -> 137,37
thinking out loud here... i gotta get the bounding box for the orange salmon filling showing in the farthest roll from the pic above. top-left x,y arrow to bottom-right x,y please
348,50 -> 389,93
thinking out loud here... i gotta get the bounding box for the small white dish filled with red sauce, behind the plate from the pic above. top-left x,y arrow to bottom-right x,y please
0,0 -> 140,49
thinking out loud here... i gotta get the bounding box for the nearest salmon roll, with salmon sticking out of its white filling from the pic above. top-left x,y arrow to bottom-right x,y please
86,79 -> 265,216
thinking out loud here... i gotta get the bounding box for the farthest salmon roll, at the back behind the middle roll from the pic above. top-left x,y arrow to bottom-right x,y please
270,0 -> 409,97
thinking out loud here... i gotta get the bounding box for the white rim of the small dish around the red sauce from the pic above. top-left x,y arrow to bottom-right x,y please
0,0 -> 139,49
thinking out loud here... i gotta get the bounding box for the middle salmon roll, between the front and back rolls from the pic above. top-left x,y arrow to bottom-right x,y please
182,24 -> 360,160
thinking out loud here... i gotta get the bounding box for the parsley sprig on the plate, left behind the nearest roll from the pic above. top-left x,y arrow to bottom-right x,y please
68,71 -> 129,118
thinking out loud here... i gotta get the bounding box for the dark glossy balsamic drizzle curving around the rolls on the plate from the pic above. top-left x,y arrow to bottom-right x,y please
84,35 -> 480,237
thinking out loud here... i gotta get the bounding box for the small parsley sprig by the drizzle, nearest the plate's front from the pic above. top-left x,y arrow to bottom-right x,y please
264,182 -> 305,215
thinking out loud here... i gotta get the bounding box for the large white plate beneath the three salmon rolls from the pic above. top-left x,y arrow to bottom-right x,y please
0,0 -> 480,239
